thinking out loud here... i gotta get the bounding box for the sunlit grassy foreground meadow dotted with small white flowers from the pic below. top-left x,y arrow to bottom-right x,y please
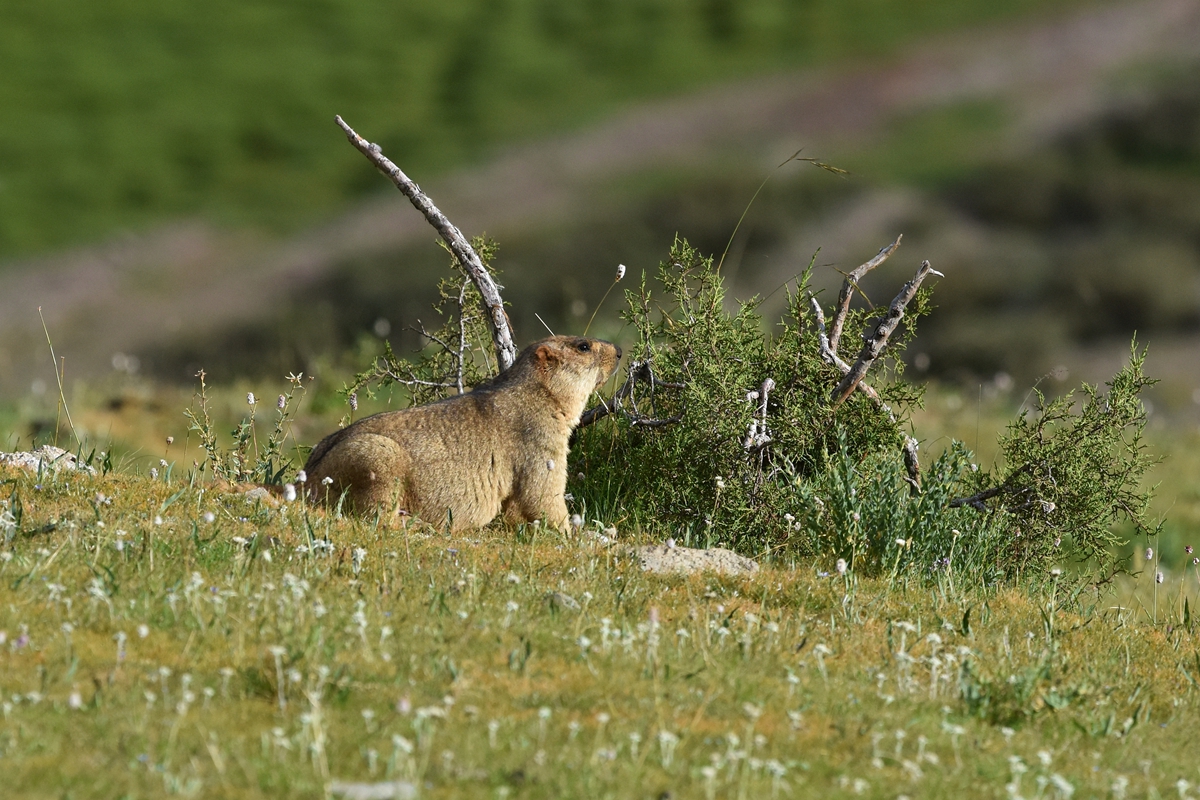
0,470 -> 1200,798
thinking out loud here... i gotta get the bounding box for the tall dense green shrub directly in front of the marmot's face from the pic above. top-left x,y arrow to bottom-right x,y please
572,241 -> 926,554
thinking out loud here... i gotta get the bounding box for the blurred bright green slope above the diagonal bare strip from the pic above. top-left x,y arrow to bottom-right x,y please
0,0 -> 1080,259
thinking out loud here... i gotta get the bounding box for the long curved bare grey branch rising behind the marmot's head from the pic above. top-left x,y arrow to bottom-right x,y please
335,116 -> 517,372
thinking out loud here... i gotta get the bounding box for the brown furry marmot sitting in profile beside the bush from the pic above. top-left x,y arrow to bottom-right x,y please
305,336 -> 620,530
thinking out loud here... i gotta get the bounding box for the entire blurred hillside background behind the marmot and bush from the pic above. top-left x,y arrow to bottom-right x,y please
0,0 -> 1200,421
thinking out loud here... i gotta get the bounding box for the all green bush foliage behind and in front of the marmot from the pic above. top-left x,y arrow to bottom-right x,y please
346,240 -> 1157,582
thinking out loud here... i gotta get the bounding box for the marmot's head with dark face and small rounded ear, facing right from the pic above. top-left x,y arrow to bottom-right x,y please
523,336 -> 620,420
